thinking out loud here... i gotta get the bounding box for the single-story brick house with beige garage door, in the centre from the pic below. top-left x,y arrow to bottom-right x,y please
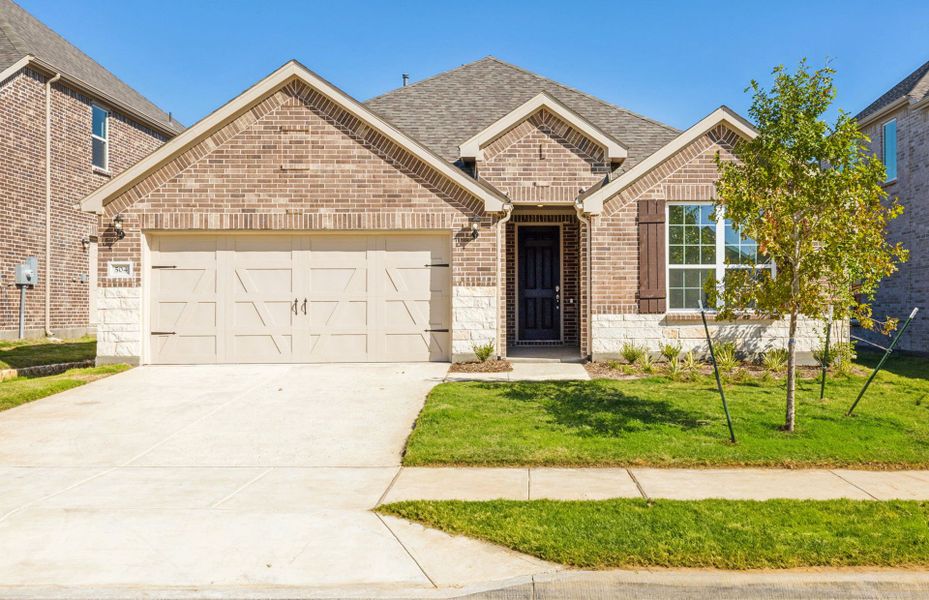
82,58 -> 821,363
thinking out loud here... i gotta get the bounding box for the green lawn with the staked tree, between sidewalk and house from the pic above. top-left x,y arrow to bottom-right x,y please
404,356 -> 929,468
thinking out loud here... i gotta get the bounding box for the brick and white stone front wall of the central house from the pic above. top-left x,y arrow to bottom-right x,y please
89,65 -> 842,360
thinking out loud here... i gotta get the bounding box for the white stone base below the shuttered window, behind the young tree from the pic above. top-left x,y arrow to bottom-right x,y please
592,314 -> 849,364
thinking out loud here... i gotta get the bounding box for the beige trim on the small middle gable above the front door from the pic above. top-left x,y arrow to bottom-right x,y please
458,92 -> 628,162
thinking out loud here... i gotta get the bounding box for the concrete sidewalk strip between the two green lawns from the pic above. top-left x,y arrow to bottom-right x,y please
383,467 -> 929,503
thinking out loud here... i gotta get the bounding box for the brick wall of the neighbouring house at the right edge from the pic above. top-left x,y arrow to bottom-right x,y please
862,106 -> 929,353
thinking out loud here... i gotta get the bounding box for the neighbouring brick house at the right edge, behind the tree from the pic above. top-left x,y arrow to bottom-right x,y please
855,62 -> 929,354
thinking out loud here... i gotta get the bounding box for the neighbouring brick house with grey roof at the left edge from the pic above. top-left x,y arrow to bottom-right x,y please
0,0 -> 182,338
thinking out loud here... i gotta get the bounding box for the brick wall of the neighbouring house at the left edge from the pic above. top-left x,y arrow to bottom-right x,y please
0,68 -> 165,337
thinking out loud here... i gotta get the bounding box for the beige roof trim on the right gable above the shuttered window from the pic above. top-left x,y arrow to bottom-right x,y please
583,106 -> 758,215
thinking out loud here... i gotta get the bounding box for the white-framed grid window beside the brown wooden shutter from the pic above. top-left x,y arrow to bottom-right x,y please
667,203 -> 773,310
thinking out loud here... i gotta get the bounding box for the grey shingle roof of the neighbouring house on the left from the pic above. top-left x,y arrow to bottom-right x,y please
0,0 -> 184,133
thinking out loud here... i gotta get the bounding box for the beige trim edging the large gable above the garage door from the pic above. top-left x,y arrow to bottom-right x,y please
80,60 -> 505,214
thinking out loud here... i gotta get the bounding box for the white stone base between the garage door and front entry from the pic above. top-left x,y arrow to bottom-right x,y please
452,286 -> 497,362
